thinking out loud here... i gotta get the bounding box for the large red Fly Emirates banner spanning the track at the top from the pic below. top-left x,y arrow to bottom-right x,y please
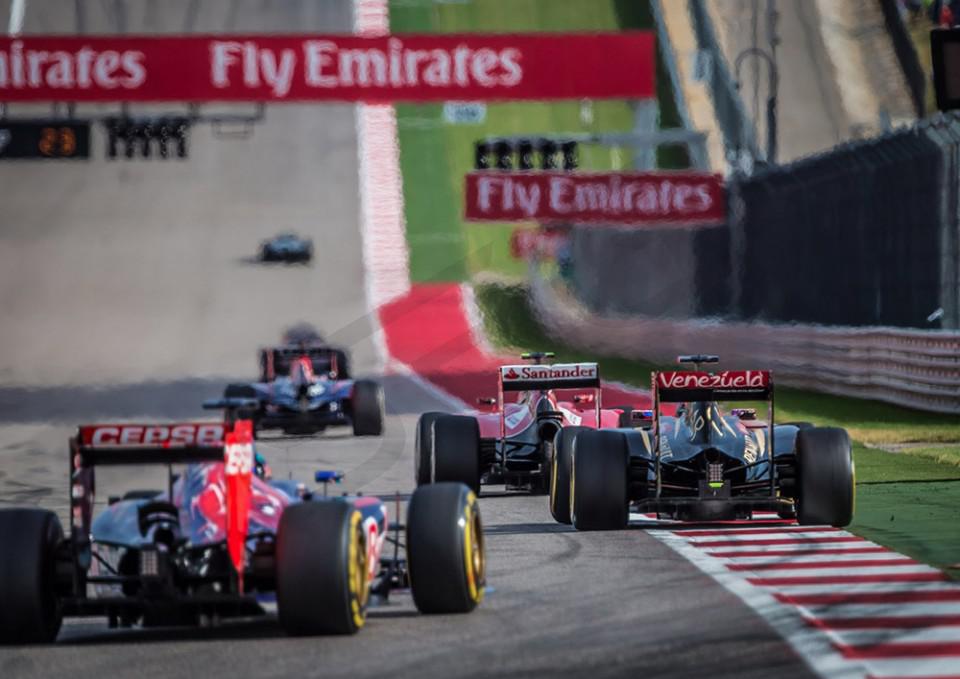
0,32 -> 655,102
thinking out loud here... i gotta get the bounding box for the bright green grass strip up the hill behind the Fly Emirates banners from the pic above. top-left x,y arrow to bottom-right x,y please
390,0 -> 687,281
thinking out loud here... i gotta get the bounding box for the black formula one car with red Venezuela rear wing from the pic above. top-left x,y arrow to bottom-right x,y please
557,355 -> 855,530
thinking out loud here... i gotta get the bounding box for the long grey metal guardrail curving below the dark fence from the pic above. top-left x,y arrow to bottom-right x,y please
530,272 -> 960,414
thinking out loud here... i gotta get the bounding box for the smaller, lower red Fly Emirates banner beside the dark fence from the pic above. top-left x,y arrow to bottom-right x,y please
465,170 -> 726,225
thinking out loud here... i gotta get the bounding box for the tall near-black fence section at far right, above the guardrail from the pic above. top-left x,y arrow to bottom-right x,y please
729,115 -> 960,328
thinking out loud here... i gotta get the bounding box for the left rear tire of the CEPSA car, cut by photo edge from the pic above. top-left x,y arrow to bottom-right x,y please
0,508 -> 63,644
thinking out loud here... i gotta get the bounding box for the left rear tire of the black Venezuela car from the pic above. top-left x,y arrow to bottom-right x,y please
570,430 -> 630,530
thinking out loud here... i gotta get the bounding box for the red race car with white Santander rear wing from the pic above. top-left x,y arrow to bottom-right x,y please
414,352 -> 630,502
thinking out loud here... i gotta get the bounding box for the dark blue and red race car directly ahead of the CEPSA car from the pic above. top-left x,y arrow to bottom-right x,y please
203,346 -> 384,436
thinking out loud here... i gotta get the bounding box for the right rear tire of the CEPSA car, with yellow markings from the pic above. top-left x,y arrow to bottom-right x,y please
276,500 -> 370,636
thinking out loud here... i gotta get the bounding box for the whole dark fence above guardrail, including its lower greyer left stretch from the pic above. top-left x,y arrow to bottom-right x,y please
571,114 -> 960,329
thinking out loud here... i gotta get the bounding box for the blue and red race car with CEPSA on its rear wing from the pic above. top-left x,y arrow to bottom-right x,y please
0,421 -> 485,643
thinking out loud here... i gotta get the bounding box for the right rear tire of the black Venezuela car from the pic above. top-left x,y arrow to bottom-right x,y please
796,427 -> 856,527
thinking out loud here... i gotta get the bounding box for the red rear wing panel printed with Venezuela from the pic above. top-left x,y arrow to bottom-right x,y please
654,370 -> 772,401
